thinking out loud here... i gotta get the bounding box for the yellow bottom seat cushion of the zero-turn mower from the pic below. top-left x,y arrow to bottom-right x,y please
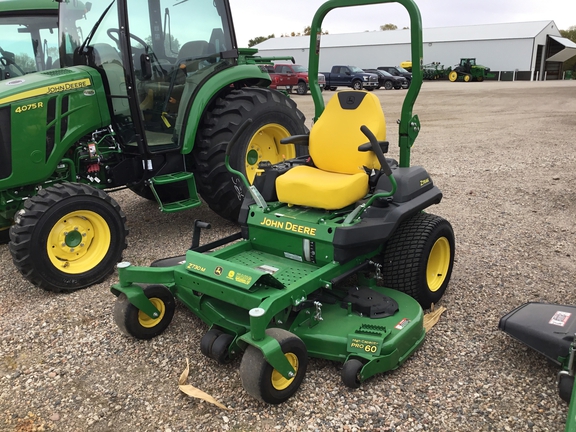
276,166 -> 368,210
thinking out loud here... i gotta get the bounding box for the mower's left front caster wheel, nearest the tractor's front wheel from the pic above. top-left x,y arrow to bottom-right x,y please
114,285 -> 176,340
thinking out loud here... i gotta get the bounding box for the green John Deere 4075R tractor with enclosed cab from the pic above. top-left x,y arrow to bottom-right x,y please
0,0 -> 307,291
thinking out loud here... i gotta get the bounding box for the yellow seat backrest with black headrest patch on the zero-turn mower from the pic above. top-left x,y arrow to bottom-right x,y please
309,91 -> 386,174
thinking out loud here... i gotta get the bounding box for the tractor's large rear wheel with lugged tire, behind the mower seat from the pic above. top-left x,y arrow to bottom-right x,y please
191,87 -> 308,222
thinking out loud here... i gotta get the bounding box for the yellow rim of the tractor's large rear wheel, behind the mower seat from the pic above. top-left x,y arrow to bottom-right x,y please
245,123 -> 296,184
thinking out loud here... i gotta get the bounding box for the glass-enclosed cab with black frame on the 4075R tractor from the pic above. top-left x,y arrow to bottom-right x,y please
60,0 -> 238,154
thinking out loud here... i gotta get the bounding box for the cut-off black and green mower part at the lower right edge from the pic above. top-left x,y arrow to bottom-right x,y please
498,302 -> 576,432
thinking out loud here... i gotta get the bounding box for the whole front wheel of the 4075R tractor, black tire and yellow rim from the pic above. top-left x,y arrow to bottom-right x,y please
9,183 -> 128,292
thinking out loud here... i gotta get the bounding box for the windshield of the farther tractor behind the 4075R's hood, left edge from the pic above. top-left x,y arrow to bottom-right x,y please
0,10 -> 58,78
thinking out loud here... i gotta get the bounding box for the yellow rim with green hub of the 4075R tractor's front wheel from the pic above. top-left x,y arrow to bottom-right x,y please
46,210 -> 111,274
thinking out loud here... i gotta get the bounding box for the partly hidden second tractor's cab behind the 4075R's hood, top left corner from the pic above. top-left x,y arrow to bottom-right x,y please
0,0 -> 58,80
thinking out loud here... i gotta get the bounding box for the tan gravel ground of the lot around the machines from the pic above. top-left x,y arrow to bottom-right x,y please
0,81 -> 576,432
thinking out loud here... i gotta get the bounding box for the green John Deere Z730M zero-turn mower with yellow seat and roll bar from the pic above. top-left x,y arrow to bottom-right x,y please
111,0 -> 455,404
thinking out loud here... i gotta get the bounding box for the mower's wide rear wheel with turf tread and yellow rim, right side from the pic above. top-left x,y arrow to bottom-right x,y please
382,213 -> 455,309
